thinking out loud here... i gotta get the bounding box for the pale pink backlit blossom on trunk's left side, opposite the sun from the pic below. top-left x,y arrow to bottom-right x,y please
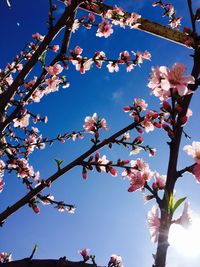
147,205 -> 160,243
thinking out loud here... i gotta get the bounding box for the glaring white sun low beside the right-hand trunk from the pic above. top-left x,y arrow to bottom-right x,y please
169,218 -> 200,258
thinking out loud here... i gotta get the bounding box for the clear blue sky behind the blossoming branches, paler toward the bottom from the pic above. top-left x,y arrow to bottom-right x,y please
0,0 -> 200,267
